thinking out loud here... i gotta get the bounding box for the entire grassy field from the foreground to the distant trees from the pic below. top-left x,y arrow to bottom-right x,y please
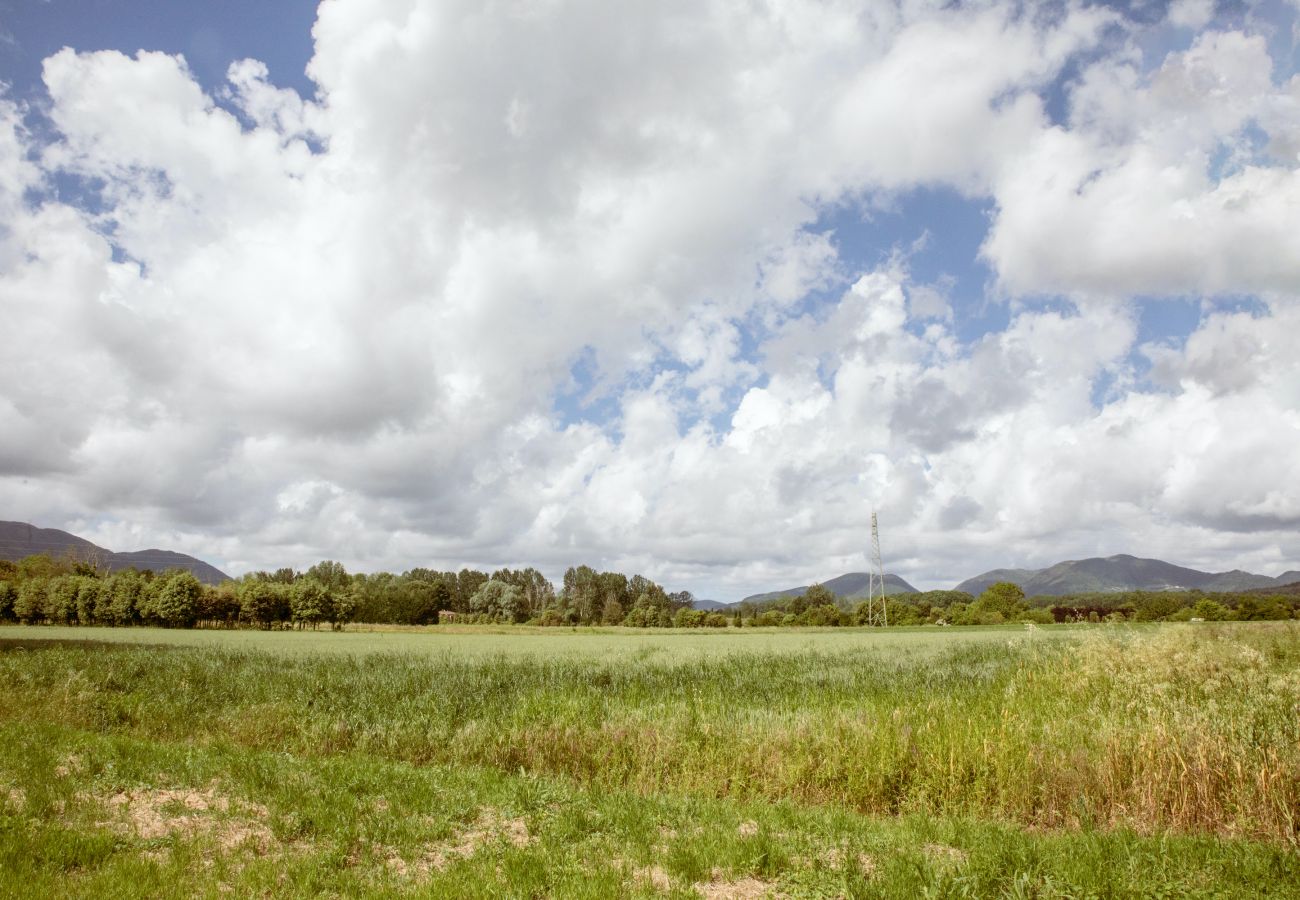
0,623 -> 1300,897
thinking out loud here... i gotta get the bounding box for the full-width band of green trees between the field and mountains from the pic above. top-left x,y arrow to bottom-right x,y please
0,554 -> 1300,628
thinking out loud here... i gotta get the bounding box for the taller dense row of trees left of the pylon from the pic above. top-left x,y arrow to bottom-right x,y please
0,554 -> 694,628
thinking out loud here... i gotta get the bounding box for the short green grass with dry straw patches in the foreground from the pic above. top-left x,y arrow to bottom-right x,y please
0,726 -> 1300,897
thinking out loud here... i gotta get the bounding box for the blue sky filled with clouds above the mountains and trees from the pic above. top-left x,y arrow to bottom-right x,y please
0,0 -> 1300,600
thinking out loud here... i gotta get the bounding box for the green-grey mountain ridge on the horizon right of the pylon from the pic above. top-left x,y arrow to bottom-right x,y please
957,554 -> 1300,597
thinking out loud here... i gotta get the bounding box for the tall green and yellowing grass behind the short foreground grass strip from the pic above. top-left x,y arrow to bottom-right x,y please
0,623 -> 1300,845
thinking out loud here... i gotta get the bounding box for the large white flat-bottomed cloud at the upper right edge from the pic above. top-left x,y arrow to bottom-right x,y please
983,31 -> 1300,297
